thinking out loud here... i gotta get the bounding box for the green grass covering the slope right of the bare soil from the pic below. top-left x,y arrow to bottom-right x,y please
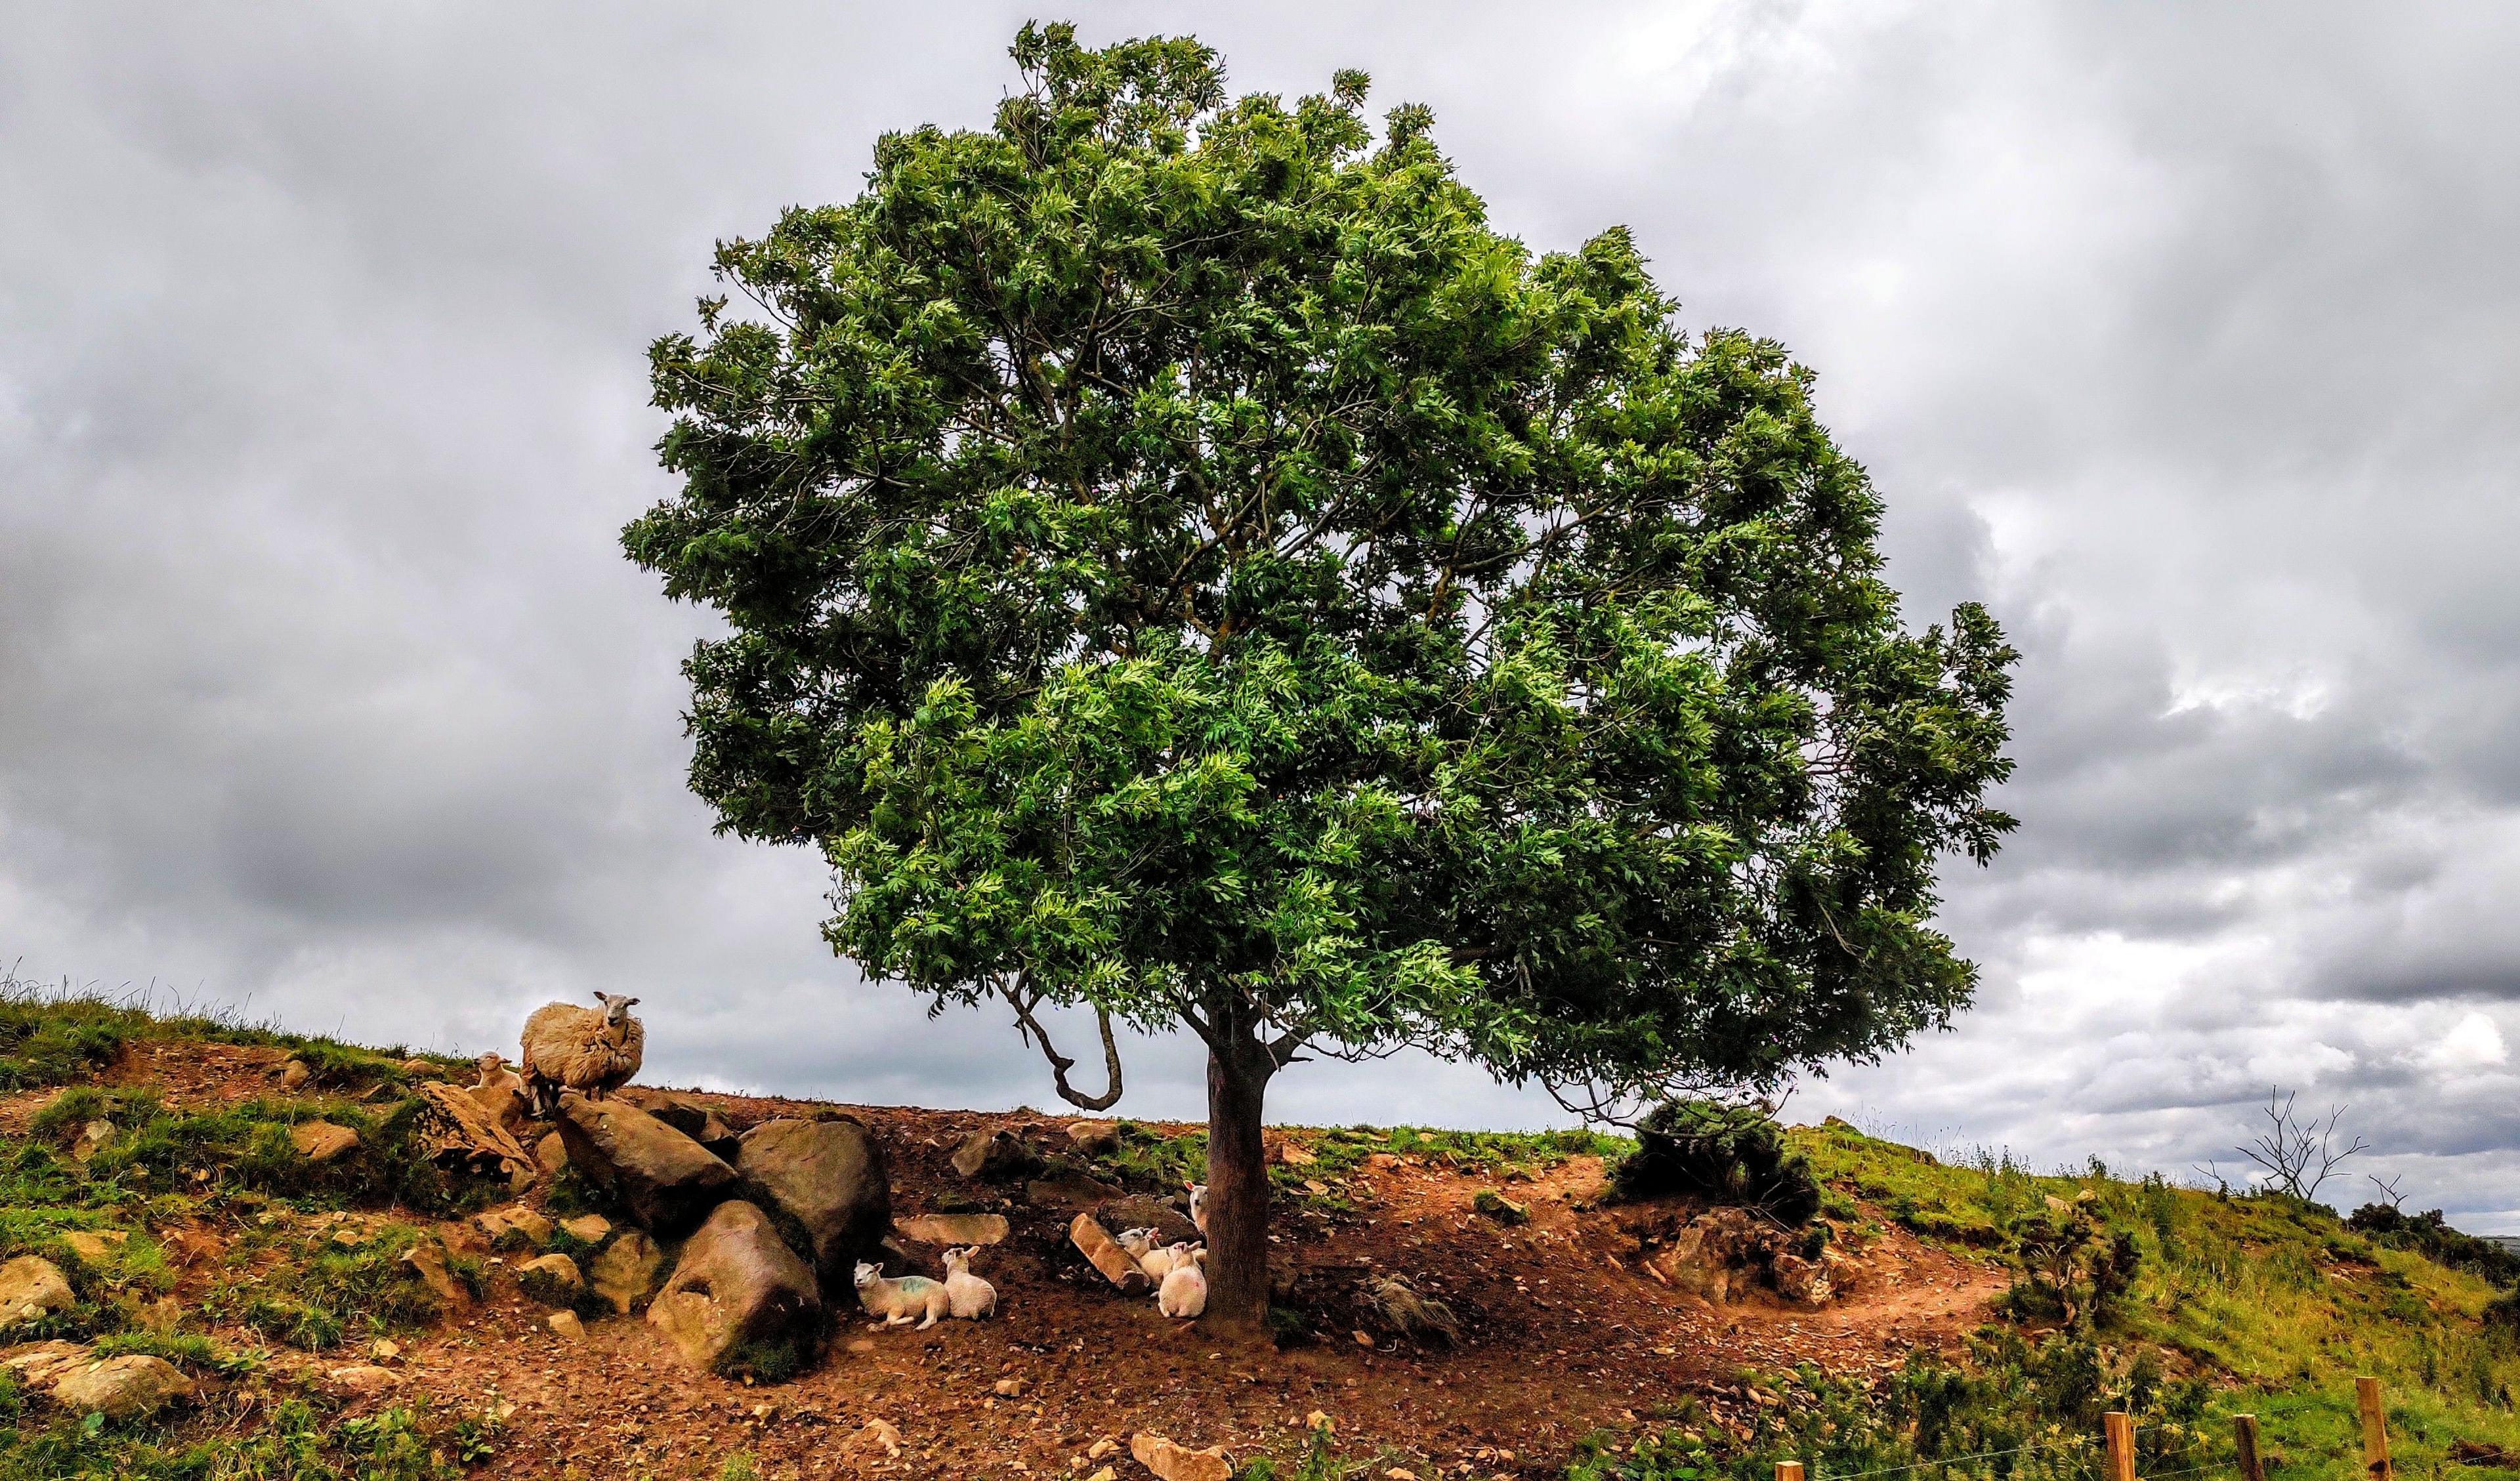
1567,1123 -> 2520,1481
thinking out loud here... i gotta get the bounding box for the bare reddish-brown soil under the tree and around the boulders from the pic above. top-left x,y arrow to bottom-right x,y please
0,1043 -> 2006,1478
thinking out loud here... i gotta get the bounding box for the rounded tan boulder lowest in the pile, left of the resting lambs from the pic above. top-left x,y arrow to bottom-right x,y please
648,1199 -> 822,1378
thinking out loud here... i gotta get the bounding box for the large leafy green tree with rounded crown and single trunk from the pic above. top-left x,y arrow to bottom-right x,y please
622,25 -> 2016,1325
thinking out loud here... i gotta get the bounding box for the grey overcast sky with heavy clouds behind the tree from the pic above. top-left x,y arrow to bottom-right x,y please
0,0 -> 2520,1229
